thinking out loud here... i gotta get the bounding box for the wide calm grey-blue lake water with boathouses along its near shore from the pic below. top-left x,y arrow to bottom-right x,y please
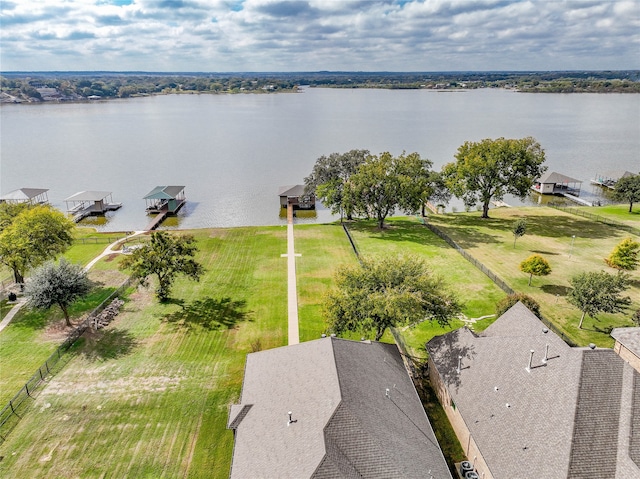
0,88 -> 640,231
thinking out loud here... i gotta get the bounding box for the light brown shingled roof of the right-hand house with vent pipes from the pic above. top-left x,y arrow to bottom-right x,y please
427,303 -> 640,479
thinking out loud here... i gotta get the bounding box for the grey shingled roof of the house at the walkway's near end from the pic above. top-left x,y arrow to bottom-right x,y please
229,338 -> 451,479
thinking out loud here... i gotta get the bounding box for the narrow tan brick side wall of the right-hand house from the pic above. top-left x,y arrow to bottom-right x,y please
429,359 -> 494,479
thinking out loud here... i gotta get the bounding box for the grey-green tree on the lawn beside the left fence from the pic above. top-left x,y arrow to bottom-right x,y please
25,258 -> 93,326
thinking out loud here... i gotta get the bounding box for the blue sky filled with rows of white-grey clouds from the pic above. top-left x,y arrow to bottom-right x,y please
0,0 -> 640,72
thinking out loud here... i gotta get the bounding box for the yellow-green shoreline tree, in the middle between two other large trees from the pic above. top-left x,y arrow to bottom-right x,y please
351,152 -> 433,229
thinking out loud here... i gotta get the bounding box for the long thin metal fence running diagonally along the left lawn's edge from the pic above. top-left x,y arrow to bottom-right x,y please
0,278 -> 132,444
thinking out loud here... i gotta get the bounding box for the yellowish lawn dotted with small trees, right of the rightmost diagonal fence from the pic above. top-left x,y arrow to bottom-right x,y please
429,207 -> 640,347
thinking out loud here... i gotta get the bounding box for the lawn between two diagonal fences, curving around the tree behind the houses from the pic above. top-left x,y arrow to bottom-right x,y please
342,217 -> 505,357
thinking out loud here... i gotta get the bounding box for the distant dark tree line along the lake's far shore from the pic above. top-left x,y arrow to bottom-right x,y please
0,70 -> 640,101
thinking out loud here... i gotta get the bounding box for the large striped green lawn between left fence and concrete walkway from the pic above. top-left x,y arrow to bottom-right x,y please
0,227 -> 287,478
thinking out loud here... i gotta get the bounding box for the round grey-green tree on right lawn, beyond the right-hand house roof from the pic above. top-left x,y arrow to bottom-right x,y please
567,271 -> 631,329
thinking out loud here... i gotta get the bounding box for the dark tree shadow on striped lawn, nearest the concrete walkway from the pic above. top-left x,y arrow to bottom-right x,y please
163,297 -> 250,331
